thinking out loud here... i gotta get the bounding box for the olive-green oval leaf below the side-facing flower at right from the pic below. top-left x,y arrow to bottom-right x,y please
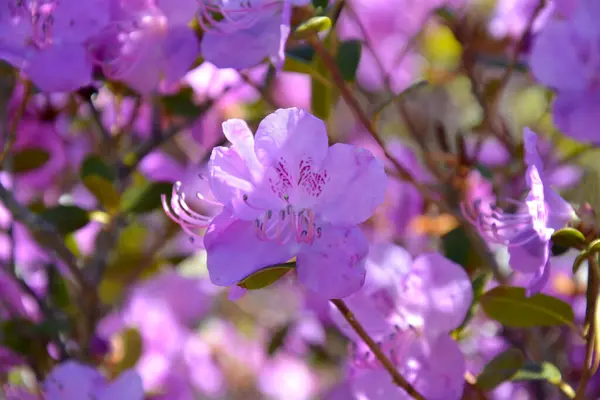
479,286 -> 574,328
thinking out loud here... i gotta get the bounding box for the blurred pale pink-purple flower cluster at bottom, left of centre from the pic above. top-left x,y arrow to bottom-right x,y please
98,272 -> 222,399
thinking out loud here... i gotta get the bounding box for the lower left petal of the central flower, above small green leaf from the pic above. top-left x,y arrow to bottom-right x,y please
204,210 -> 296,286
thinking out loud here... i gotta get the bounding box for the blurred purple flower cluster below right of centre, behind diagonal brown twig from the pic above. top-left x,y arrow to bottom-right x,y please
332,246 -> 473,400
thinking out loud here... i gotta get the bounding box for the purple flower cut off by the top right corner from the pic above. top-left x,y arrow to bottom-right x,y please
529,0 -> 600,144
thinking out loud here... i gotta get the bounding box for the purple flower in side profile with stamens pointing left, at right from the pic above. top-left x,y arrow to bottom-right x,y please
465,129 -> 575,295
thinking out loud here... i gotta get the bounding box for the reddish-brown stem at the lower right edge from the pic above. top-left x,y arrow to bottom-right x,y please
575,254 -> 600,400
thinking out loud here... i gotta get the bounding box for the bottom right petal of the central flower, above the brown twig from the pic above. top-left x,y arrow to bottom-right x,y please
296,225 -> 369,299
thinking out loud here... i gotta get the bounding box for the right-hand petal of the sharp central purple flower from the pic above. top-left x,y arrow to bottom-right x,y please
315,143 -> 387,226
